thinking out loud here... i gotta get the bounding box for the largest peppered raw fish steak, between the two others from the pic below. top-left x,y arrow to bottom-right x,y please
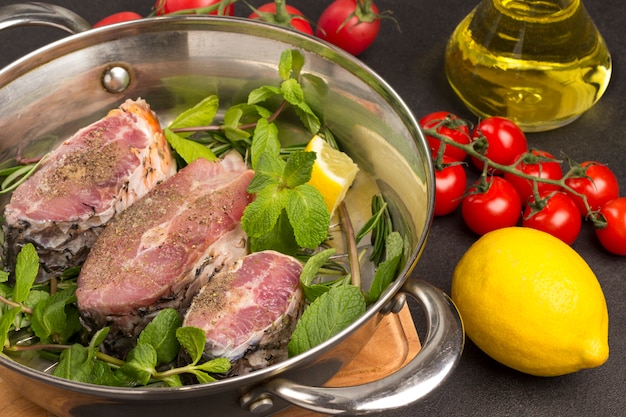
76,152 -> 254,353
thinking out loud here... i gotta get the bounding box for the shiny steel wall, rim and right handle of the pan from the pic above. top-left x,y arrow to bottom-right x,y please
0,4 -> 463,417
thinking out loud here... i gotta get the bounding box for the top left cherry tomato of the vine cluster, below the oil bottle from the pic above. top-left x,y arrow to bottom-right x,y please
420,111 -> 470,161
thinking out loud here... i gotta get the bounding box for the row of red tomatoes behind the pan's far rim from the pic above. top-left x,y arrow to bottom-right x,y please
94,0 -> 383,55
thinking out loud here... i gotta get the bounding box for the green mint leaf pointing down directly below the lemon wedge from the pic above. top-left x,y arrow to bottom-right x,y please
286,184 -> 330,249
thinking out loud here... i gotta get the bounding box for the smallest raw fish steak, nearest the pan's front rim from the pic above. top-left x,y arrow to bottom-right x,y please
183,251 -> 303,376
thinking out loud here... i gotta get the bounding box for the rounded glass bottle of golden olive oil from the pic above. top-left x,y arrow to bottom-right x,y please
445,0 -> 611,131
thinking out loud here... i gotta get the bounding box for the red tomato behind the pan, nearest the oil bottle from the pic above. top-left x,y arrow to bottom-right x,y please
315,0 -> 380,55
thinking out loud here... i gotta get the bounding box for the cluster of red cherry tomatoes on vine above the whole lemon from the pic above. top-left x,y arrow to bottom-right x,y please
420,112 -> 626,255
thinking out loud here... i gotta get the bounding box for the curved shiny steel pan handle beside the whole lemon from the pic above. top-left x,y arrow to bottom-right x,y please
241,279 -> 465,415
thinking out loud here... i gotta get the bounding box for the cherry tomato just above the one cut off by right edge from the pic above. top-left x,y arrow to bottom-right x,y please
565,161 -> 619,217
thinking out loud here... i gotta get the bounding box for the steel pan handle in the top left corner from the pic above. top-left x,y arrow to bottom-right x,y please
0,2 -> 91,34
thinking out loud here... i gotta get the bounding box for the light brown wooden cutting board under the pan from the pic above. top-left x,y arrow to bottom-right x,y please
0,306 -> 420,417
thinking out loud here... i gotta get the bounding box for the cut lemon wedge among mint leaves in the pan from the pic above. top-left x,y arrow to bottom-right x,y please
305,135 -> 359,216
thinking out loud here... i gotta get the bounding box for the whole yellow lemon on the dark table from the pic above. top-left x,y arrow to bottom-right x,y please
451,227 -> 609,376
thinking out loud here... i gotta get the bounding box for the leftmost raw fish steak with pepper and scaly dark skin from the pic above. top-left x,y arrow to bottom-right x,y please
4,99 -> 176,281
